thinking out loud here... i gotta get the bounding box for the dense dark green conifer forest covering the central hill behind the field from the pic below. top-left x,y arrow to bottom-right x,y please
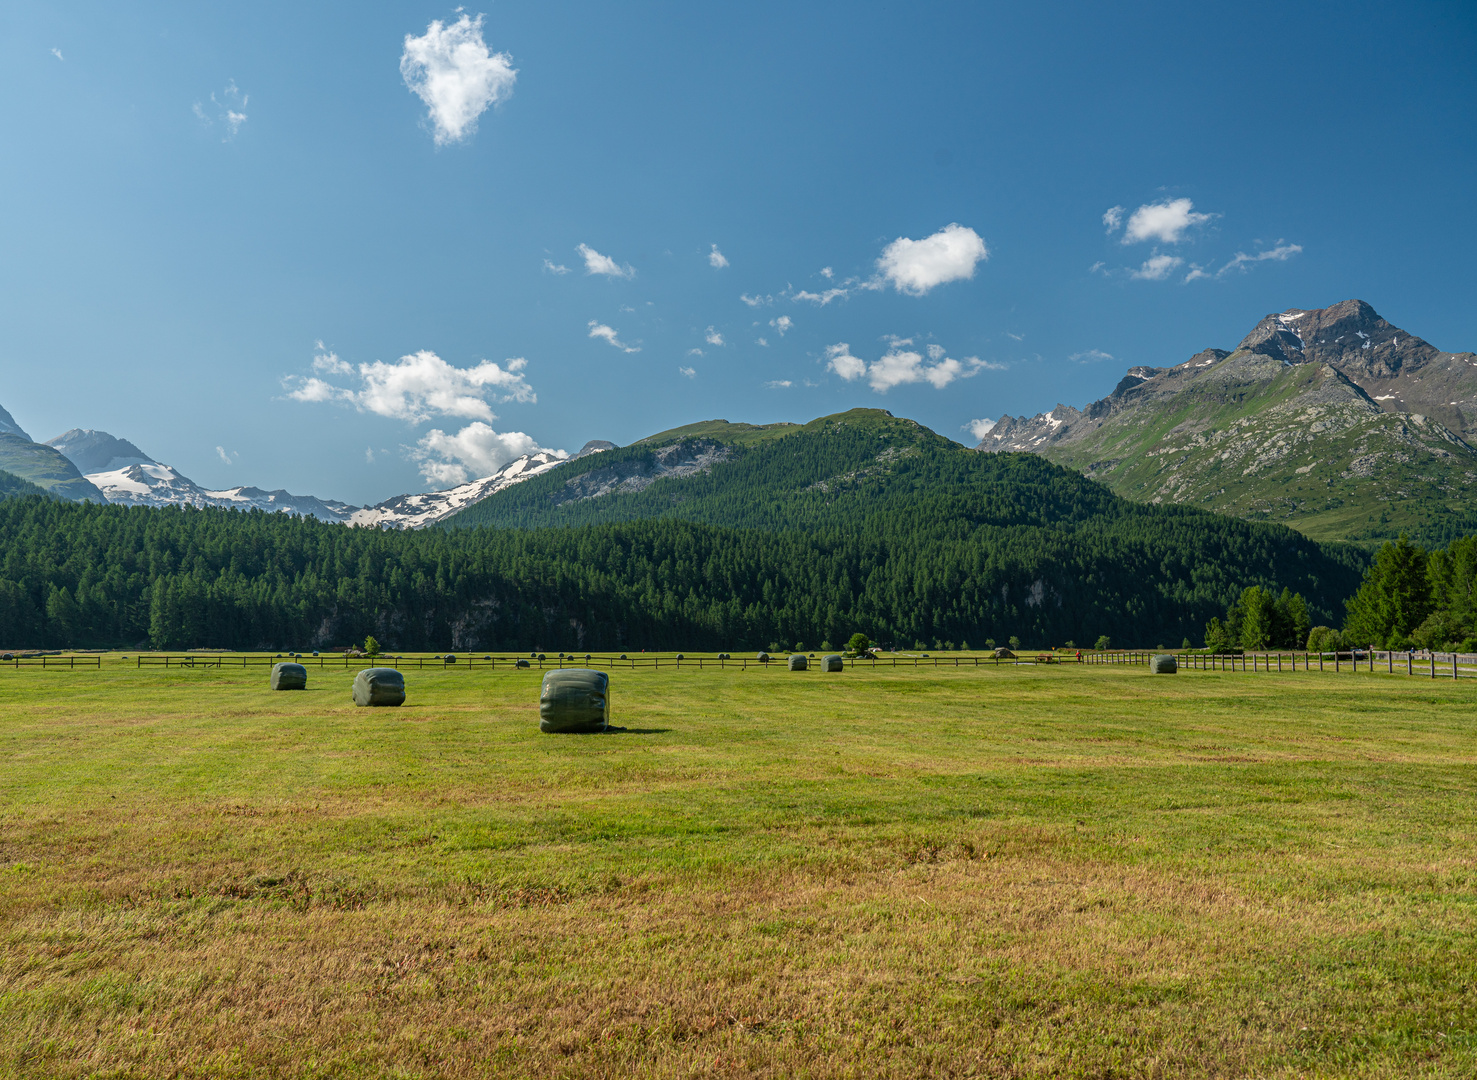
0,421 -> 1368,652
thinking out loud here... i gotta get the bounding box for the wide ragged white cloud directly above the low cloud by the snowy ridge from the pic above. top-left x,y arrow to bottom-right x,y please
284,349 -> 538,424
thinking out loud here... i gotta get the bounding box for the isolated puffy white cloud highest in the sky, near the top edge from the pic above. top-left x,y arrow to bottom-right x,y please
400,13 -> 518,146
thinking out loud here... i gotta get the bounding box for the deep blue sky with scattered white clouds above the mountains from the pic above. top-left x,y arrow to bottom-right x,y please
0,0 -> 1477,502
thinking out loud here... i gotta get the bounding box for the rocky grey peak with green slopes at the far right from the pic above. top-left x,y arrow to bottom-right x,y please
979,300 -> 1477,539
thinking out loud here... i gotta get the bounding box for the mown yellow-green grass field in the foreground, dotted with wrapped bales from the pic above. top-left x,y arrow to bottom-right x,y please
0,660 -> 1477,1077
